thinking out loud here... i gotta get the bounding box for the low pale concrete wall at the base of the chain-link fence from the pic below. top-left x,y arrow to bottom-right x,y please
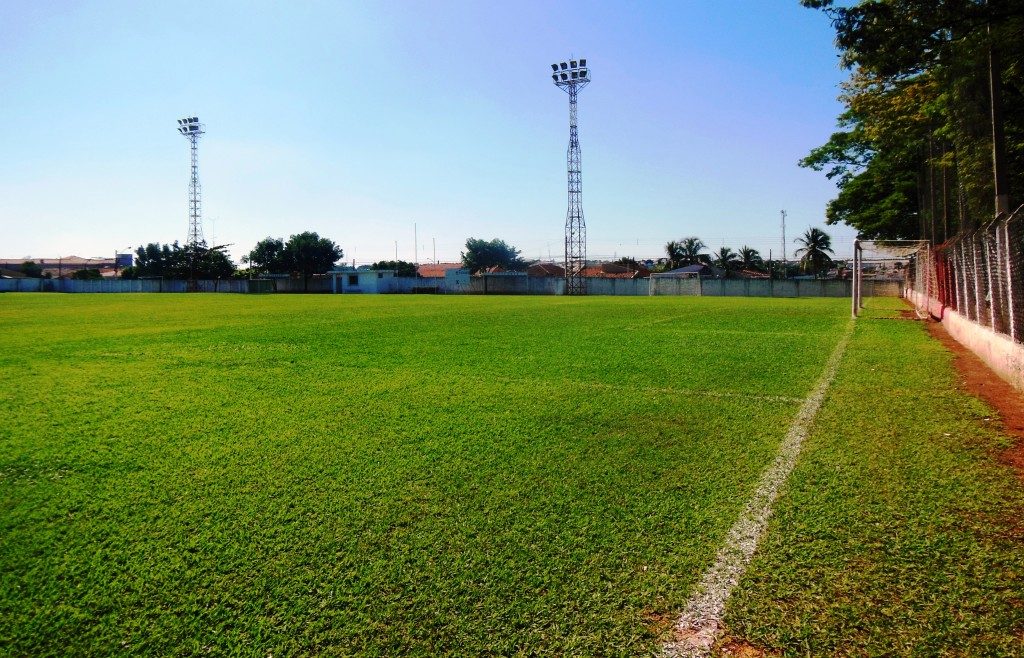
906,290 -> 1024,391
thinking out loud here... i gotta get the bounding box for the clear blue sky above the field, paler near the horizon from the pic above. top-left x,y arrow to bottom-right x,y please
0,0 -> 854,263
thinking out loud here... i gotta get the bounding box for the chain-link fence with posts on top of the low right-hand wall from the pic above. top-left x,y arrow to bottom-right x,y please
910,206 -> 1024,343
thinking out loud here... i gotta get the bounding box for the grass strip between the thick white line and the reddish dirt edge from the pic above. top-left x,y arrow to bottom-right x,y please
726,300 -> 1024,656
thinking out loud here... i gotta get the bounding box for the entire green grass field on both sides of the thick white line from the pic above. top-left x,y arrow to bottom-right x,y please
0,294 -> 1024,656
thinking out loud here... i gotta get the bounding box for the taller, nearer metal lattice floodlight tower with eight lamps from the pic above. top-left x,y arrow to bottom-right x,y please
551,59 -> 590,295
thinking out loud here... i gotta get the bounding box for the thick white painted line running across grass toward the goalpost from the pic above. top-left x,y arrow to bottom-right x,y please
663,321 -> 853,658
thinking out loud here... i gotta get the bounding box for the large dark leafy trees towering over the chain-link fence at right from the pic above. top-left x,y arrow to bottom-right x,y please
801,0 -> 1024,243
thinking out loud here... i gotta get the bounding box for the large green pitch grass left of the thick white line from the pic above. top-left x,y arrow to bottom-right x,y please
0,294 -> 847,656
